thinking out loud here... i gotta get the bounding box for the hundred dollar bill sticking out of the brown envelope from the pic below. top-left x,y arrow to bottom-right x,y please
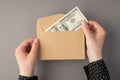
45,7 -> 88,32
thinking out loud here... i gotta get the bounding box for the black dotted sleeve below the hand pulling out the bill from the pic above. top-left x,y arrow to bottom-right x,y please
84,59 -> 110,80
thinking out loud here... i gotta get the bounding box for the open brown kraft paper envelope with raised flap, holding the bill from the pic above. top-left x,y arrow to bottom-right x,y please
37,14 -> 85,60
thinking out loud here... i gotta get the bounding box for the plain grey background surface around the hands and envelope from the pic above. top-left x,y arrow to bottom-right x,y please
0,0 -> 120,80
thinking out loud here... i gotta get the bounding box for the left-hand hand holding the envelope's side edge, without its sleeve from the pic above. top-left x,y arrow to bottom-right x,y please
15,39 -> 39,77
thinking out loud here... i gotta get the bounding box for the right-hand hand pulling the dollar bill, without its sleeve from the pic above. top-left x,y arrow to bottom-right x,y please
82,21 -> 106,62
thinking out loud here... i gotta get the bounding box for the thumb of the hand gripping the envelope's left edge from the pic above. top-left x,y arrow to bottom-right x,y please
29,39 -> 39,58
